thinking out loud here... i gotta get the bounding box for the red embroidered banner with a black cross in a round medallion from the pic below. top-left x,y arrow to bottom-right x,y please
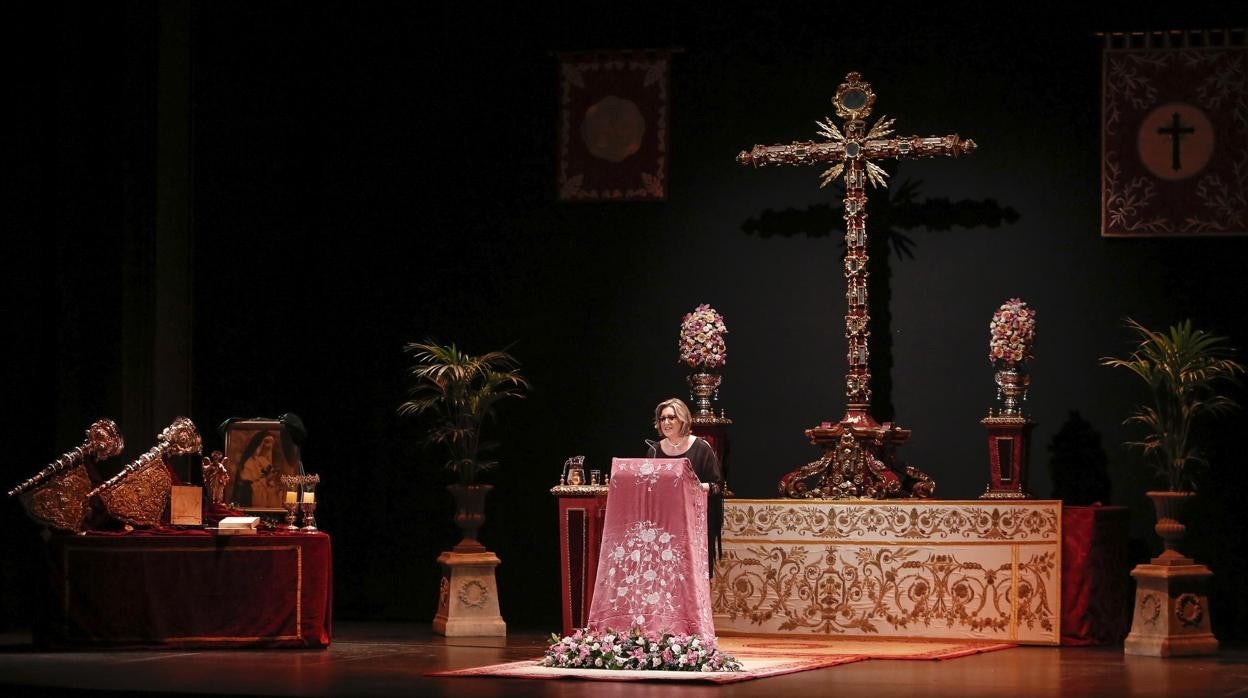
1101,32 -> 1248,237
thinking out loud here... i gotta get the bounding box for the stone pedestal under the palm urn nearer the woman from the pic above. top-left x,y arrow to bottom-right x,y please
433,548 -> 507,637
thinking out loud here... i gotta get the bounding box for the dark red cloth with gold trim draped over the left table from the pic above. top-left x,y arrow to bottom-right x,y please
35,529 -> 333,648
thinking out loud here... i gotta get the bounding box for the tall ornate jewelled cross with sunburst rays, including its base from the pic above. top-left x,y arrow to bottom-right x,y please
736,72 -> 975,498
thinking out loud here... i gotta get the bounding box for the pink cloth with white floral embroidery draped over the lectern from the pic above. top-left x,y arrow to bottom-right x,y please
589,458 -> 715,638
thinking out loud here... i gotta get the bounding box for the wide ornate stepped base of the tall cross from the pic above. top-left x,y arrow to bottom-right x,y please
779,405 -> 936,499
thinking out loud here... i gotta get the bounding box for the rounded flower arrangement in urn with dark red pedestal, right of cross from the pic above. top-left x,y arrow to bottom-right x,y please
980,298 -> 1036,499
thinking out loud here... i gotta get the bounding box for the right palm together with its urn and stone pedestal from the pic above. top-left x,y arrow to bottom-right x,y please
1101,318 -> 1244,657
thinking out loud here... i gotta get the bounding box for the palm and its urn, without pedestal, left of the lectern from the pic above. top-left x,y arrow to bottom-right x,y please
398,340 -> 529,552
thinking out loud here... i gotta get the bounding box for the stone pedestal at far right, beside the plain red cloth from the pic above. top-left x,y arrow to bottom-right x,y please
1123,554 -> 1218,657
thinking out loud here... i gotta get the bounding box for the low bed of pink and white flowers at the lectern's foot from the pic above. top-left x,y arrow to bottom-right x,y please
542,628 -> 744,672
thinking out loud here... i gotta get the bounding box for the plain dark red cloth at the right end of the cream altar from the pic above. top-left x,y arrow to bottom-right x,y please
1062,507 -> 1128,646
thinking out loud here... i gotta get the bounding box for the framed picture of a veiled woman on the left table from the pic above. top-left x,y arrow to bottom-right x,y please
225,420 -> 303,513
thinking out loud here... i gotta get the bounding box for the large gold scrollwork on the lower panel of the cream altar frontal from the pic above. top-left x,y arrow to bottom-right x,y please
711,546 -> 1056,636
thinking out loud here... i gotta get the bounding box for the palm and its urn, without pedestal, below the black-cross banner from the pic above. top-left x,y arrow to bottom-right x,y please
1101,317 -> 1244,562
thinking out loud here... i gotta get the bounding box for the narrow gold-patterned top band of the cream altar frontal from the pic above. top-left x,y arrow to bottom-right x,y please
724,502 -> 1058,541
